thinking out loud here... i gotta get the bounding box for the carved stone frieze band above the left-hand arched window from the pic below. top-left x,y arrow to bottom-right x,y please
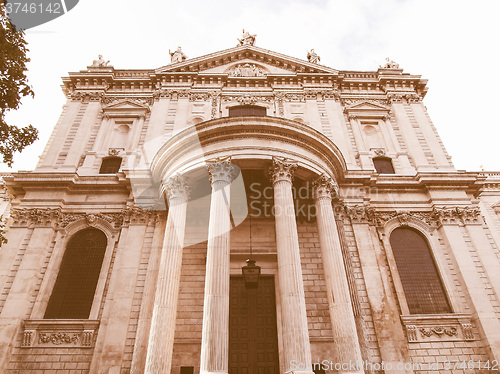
11,207 -> 164,228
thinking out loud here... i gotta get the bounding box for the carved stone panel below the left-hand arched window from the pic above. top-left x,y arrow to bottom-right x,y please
21,319 -> 99,348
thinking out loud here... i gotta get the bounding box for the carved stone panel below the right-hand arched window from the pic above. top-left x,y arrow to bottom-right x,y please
401,314 -> 474,343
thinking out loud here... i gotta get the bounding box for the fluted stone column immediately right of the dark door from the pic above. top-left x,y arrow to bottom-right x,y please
271,158 -> 312,373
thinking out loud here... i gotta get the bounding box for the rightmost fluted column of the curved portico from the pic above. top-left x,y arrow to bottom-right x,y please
314,175 -> 364,373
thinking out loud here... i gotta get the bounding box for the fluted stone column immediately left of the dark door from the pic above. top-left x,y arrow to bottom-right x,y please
200,160 -> 236,374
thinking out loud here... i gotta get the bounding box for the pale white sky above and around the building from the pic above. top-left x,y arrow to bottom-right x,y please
0,0 -> 500,171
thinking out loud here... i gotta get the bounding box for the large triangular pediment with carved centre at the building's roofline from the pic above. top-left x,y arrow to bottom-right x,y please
156,45 -> 338,77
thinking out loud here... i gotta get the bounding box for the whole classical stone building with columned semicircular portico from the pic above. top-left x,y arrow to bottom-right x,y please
0,33 -> 500,374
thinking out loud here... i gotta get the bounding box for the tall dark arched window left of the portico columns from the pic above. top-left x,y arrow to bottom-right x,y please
44,228 -> 107,319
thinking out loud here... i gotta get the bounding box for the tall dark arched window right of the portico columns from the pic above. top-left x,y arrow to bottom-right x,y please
390,227 -> 451,314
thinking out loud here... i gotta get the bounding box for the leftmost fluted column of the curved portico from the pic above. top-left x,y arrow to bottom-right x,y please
145,175 -> 188,374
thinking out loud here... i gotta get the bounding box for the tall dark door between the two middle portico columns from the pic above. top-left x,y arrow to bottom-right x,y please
229,276 -> 279,374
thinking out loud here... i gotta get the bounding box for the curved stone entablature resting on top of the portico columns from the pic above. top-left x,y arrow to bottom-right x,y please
151,117 -> 347,181
